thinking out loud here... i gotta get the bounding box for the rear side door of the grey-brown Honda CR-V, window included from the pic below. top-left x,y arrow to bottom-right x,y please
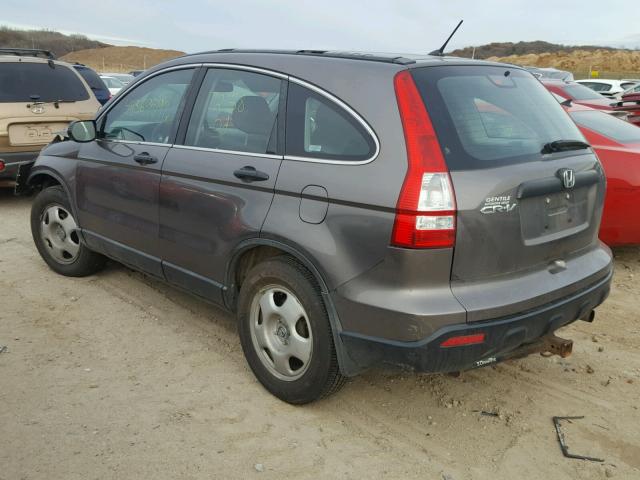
160,67 -> 286,302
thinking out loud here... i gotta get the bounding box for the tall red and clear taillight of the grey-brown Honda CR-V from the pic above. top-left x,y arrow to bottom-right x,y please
391,70 -> 456,248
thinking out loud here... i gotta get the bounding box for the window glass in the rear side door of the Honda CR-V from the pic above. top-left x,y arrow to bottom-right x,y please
185,69 -> 281,153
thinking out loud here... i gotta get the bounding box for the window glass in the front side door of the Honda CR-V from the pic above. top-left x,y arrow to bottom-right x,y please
101,69 -> 193,143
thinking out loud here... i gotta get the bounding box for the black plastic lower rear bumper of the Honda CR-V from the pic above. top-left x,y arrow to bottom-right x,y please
340,271 -> 613,373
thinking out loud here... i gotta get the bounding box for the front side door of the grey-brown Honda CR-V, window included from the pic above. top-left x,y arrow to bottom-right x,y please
76,68 -> 194,277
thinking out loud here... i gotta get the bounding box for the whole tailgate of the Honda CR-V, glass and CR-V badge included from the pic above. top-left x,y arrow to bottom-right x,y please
412,65 -> 610,321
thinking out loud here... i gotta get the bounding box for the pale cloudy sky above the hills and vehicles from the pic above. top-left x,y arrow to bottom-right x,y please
0,0 -> 640,53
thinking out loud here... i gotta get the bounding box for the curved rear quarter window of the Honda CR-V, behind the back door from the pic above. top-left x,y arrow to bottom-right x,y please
286,83 -> 375,161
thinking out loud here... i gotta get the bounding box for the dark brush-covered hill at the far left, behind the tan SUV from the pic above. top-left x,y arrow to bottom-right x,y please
0,26 -> 108,57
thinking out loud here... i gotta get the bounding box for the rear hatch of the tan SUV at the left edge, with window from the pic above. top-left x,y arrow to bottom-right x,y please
0,59 -> 98,151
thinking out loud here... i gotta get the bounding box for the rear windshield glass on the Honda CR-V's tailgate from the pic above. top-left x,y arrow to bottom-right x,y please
412,66 -> 584,170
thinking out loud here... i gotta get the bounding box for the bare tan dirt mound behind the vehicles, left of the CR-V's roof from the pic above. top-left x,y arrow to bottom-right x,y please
61,46 -> 184,72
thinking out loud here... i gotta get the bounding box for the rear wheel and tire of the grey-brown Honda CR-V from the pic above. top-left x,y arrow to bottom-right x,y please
238,256 -> 346,405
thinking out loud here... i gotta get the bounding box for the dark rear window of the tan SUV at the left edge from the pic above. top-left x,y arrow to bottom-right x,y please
0,62 -> 89,103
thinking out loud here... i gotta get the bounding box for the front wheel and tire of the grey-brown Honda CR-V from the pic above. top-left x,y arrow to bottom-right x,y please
31,185 -> 106,277
